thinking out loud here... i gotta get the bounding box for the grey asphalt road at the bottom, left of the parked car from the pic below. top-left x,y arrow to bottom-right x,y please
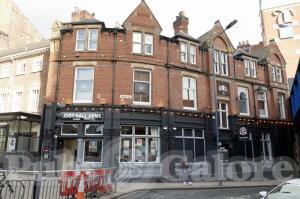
119,185 -> 271,199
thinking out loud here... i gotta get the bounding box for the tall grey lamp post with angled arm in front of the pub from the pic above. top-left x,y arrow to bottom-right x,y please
212,19 -> 237,186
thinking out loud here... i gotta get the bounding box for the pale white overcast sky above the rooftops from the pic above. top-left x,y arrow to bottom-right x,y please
14,0 -> 300,46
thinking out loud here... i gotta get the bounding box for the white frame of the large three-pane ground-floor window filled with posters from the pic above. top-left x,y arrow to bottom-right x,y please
119,125 -> 161,164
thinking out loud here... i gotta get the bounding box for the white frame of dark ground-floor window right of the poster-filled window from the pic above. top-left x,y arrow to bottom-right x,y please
175,128 -> 207,163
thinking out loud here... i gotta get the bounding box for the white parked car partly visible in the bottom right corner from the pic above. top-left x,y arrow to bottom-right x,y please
259,178 -> 300,199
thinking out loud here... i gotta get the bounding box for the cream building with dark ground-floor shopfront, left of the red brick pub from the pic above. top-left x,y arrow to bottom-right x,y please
0,40 -> 50,165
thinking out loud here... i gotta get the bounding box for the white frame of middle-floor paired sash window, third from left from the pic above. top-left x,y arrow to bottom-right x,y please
182,76 -> 197,110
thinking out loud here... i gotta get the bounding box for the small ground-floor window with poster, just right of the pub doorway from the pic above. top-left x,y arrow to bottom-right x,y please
83,139 -> 103,163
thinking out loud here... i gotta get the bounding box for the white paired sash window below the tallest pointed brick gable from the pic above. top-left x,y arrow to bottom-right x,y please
132,32 -> 153,55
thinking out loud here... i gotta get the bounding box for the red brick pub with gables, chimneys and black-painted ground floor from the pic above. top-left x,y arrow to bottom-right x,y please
46,1 -> 291,176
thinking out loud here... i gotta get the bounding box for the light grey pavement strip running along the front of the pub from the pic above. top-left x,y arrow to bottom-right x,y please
101,180 -> 281,199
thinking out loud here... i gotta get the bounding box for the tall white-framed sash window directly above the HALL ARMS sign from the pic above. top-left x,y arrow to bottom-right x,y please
73,67 -> 94,103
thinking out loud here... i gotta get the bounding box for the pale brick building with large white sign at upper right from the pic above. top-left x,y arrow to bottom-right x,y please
260,0 -> 300,86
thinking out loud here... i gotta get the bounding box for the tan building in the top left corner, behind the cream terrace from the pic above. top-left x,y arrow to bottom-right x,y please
0,0 -> 43,51
